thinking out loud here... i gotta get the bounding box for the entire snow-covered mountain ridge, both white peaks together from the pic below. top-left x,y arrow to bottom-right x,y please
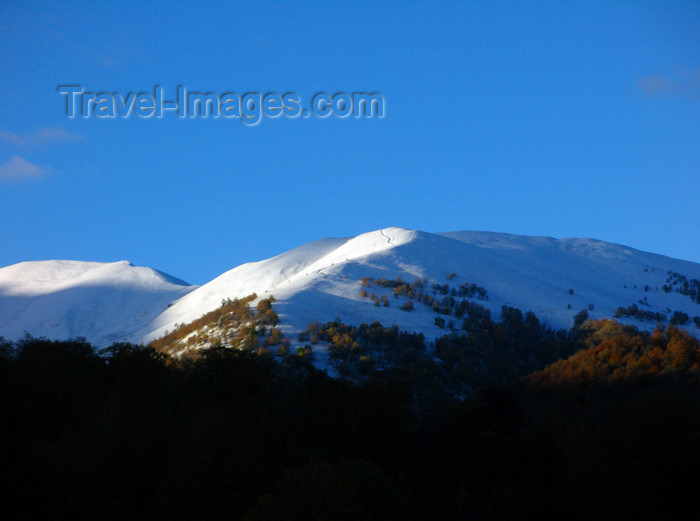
0,228 -> 700,345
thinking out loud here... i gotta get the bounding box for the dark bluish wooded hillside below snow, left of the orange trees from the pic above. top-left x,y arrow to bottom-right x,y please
308,300 -> 585,396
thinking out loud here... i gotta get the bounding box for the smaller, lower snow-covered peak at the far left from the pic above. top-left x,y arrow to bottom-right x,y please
0,260 -> 197,346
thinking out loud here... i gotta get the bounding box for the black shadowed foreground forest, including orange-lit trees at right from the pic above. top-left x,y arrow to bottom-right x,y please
0,321 -> 700,521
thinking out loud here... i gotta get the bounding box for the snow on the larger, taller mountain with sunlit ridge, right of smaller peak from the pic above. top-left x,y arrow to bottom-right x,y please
135,228 -> 700,341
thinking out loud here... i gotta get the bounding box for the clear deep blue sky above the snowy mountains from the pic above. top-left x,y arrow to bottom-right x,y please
0,1 -> 700,284
